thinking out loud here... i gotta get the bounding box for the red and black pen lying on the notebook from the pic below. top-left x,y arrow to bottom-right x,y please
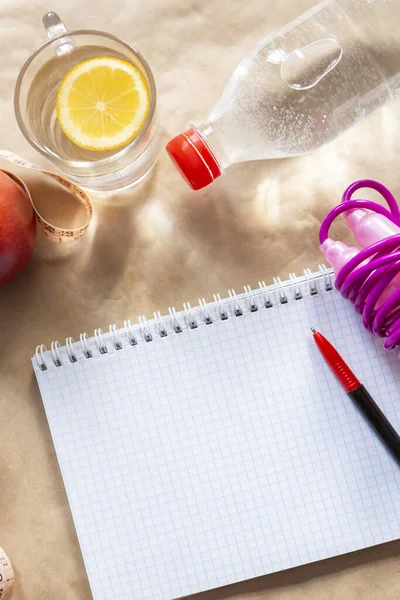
311,328 -> 400,463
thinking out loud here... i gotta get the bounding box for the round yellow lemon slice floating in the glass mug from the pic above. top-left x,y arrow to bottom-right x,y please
56,56 -> 150,150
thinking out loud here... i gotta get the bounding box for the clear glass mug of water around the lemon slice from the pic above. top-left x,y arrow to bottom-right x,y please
14,12 -> 160,191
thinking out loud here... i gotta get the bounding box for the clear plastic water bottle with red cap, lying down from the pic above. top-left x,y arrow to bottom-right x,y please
167,0 -> 400,189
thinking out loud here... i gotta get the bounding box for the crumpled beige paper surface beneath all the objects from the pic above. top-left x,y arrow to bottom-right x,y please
0,0 -> 400,600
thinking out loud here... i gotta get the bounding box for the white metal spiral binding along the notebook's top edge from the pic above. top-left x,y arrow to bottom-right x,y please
35,265 -> 333,371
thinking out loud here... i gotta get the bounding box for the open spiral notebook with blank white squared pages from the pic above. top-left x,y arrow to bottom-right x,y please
33,268 -> 400,600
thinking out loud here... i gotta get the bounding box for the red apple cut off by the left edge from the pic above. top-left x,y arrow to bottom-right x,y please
0,171 -> 36,285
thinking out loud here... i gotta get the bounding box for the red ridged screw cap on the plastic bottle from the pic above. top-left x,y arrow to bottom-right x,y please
166,128 -> 222,190
